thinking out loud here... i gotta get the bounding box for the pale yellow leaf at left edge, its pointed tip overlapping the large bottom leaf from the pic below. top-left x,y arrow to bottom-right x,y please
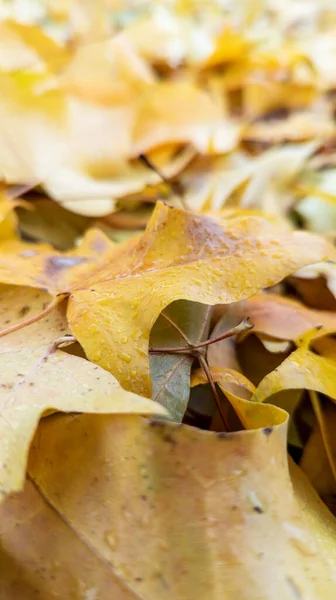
0,286 -> 165,499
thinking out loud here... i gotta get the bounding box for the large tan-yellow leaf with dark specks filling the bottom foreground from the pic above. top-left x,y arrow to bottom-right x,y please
1,412 -> 335,600
